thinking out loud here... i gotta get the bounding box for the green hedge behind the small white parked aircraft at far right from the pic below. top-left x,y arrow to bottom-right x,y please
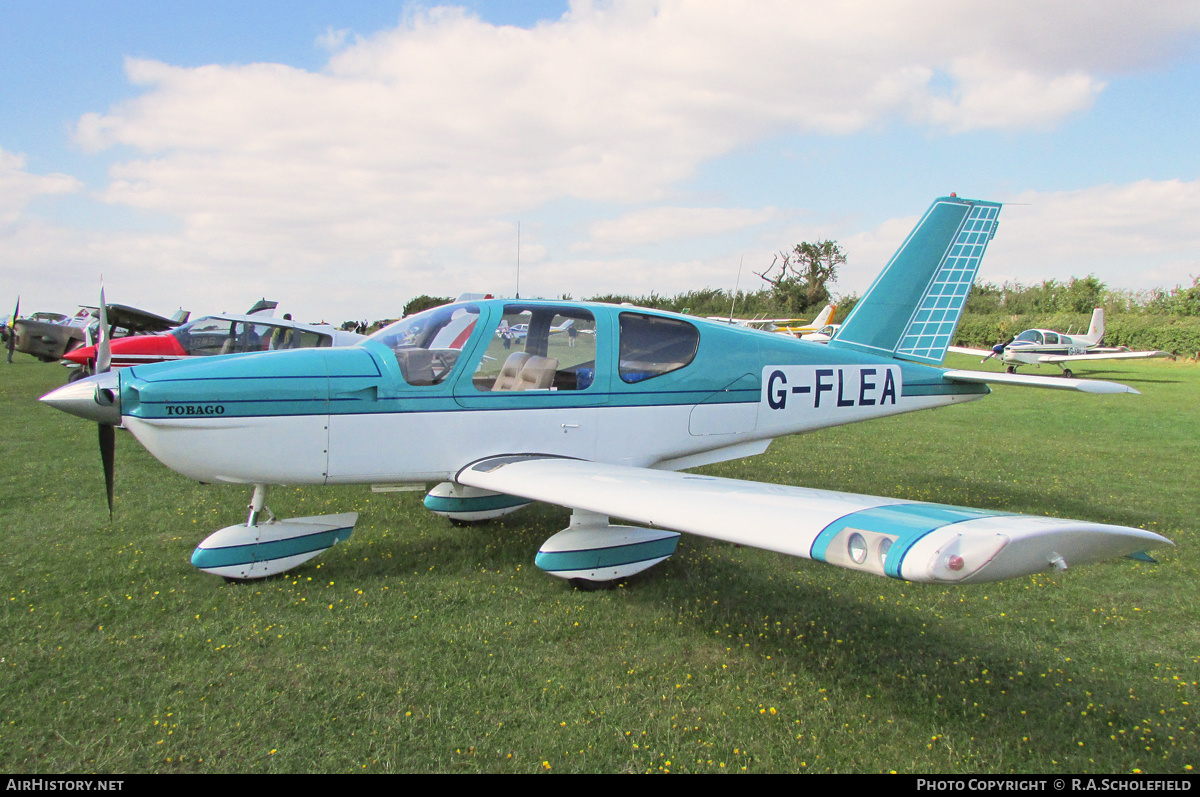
955,313 -> 1200,359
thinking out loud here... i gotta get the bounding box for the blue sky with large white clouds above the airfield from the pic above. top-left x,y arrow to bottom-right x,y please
0,0 -> 1200,320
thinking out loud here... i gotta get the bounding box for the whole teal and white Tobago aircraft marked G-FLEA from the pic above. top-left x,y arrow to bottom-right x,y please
42,196 -> 1171,586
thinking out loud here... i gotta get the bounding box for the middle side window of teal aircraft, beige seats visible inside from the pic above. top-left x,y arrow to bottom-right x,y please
472,304 -> 596,392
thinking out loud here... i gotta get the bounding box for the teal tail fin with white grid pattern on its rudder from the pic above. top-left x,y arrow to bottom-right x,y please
829,196 -> 1001,365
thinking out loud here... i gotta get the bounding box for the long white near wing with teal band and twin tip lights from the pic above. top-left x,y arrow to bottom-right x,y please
455,455 -> 1171,583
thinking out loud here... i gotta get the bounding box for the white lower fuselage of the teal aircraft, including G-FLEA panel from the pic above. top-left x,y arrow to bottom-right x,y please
124,366 -> 984,484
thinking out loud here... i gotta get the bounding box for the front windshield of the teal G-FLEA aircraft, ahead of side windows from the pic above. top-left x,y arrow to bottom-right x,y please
368,304 -> 479,385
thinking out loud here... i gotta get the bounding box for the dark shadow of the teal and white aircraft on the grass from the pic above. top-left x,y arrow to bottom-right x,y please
331,507 -> 1183,769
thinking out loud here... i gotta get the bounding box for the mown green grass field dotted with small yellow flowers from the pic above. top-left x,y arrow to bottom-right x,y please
0,355 -> 1200,773
